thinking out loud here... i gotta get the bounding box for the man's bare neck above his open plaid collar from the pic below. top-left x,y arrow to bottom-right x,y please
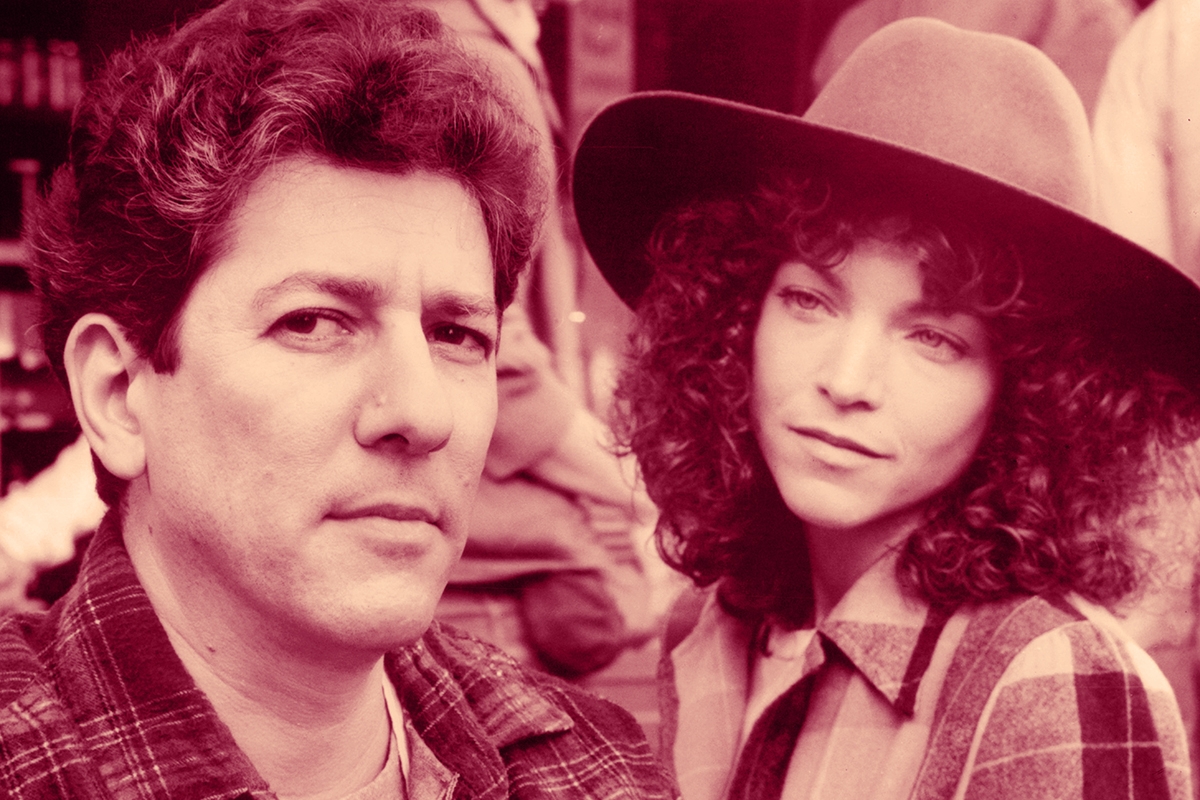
126,522 -> 391,800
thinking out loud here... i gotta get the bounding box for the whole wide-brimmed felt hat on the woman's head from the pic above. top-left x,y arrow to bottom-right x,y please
572,18 -> 1200,386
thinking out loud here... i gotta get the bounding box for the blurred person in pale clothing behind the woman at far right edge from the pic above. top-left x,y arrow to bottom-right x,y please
1092,0 -> 1200,782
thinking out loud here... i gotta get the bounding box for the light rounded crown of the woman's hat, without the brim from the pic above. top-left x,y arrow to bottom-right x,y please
804,19 -> 1096,218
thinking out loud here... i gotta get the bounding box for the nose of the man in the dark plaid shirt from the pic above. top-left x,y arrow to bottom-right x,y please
354,323 -> 454,455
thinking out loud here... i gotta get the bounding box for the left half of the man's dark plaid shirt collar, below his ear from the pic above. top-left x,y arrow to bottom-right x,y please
50,512 -> 270,799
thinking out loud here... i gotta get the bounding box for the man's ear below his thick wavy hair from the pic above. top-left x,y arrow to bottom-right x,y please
62,313 -> 150,480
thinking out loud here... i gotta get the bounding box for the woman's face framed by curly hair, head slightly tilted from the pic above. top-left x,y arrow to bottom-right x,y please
751,240 -> 997,535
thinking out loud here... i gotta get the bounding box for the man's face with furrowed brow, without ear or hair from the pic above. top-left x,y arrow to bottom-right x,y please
126,160 -> 498,650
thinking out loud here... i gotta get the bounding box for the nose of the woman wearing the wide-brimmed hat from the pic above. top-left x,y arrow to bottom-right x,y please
817,323 -> 888,409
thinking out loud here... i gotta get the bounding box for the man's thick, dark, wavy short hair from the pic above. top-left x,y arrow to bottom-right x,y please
30,0 -> 547,505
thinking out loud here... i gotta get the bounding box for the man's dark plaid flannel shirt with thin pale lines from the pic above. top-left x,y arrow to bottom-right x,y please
0,519 -> 674,800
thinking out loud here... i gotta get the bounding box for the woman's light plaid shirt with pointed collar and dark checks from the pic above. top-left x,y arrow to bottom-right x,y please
661,558 -> 1192,800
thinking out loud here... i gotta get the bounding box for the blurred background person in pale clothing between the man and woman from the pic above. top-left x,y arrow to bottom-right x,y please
410,0 -> 658,678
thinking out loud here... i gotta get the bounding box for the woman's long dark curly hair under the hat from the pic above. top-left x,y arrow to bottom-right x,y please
616,179 -> 1200,626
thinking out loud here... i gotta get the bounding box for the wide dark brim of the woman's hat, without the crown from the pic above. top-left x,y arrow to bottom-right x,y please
572,92 -> 1200,386
